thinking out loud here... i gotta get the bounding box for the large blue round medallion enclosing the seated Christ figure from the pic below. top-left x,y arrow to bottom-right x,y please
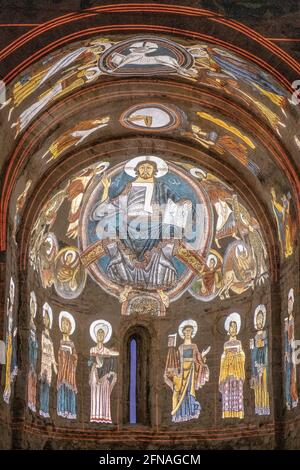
79,156 -> 212,300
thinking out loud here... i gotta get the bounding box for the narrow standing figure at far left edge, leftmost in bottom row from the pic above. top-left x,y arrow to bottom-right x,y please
3,278 -> 18,404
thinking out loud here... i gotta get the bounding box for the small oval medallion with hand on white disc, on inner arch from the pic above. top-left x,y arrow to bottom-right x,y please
120,103 -> 182,132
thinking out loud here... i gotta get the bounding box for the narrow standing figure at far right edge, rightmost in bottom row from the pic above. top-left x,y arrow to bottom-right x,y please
284,289 -> 298,410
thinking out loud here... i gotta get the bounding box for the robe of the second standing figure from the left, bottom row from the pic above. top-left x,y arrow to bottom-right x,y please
27,322 -> 39,413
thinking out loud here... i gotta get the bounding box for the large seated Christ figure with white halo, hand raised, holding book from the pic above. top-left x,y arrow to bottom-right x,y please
91,156 -> 193,289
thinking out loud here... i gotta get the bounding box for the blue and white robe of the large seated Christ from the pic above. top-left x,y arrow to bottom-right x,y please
91,180 -> 192,289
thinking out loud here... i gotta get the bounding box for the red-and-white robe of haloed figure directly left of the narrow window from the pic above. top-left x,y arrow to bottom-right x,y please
88,346 -> 119,424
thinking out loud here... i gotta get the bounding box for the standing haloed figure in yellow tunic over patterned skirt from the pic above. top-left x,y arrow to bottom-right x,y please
219,313 -> 245,419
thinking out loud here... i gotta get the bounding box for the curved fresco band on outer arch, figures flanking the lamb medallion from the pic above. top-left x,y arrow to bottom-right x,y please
1,35 -> 290,136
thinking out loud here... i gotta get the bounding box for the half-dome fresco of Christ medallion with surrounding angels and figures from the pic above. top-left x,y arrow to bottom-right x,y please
29,155 -> 268,316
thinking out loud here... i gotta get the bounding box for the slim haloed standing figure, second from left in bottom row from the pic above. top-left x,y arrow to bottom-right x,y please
27,291 -> 39,413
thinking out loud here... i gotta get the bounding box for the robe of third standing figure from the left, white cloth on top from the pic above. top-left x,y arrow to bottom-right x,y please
40,330 -> 56,418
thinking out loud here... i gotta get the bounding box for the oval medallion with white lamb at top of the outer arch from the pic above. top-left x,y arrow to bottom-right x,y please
99,37 -> 194,75
